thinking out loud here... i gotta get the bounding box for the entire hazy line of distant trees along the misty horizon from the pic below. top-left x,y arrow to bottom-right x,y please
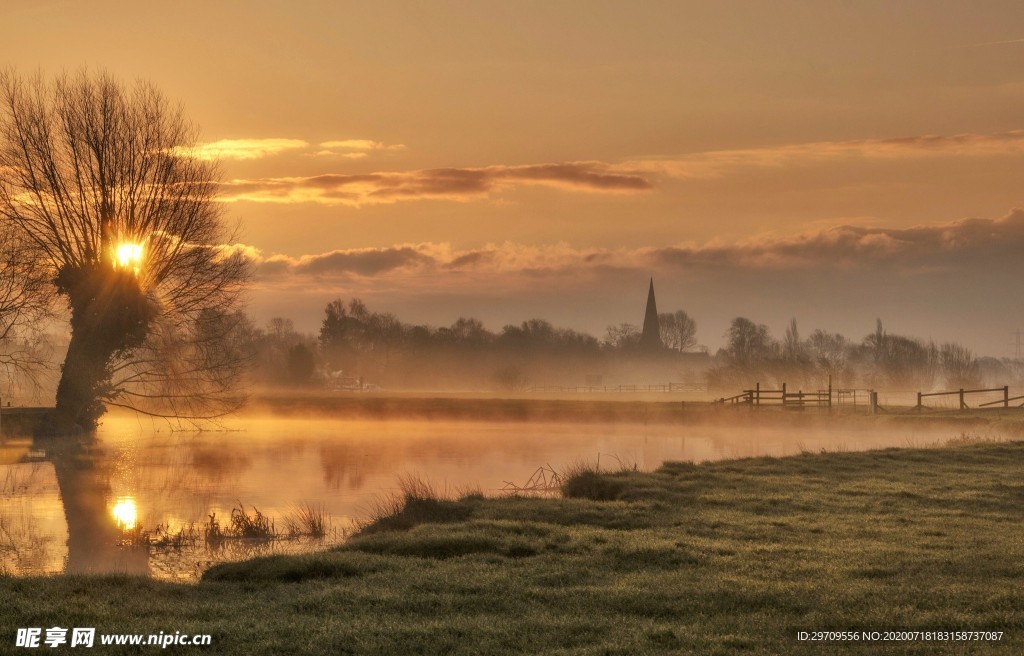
232,299 -> 1024,391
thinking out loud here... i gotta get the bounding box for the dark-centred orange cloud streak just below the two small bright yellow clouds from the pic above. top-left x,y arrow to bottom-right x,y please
220,162 -> 652,207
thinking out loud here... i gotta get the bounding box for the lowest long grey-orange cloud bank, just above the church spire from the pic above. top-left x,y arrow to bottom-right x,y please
241,210 -> 1024,285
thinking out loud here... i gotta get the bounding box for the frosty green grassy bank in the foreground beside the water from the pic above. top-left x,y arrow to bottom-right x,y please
0,442 -> 1024,654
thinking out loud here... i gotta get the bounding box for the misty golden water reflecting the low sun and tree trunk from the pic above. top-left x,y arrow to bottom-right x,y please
0,418 -> 995,579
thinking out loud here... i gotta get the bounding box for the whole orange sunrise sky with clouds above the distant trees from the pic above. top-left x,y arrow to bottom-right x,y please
6,0 -> 1024,355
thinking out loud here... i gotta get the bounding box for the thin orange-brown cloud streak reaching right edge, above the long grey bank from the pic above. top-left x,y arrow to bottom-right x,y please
623,130 -> 1024,179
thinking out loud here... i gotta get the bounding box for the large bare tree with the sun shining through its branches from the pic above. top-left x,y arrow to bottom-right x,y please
0,72 -> 249,430
